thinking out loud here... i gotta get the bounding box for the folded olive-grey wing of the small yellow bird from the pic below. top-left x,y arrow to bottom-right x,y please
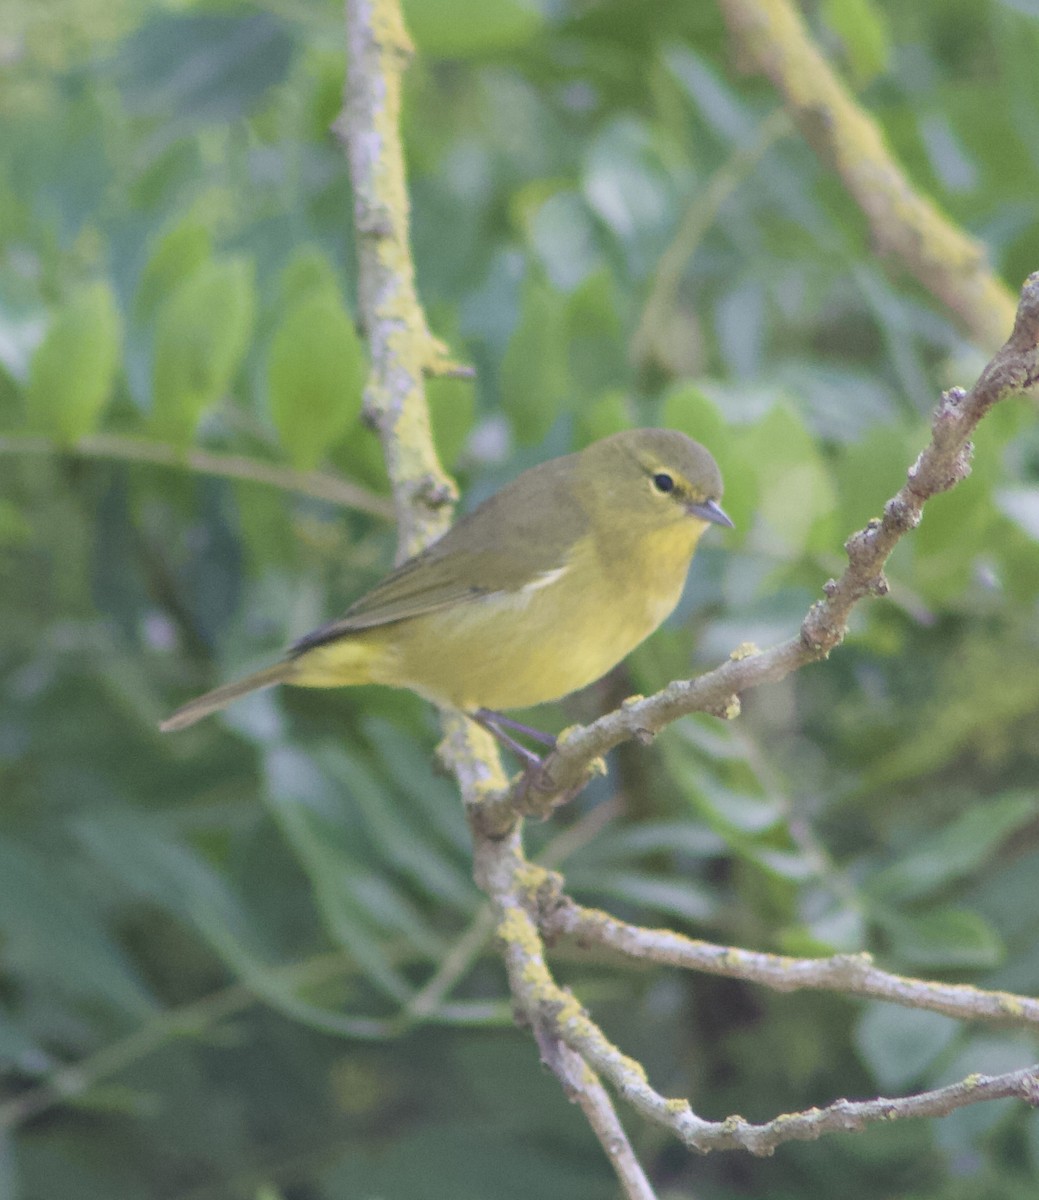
289,458 -> 587,655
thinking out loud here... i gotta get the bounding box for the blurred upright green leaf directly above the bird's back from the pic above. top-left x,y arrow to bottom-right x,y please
499,281 -> 570,445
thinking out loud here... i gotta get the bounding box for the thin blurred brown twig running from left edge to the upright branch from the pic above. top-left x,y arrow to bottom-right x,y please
0,433 -> 392,517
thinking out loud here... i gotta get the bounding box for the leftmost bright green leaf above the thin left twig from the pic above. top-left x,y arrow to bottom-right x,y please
25,280 -> 122,442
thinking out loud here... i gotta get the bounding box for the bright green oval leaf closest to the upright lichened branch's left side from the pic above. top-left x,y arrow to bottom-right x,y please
268,289 -> 367,470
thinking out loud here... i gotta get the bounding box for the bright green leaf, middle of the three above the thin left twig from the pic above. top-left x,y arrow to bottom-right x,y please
152,257 -> 256,446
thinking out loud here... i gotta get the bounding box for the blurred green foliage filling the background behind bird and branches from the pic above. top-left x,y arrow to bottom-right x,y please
0,0 -> 1039,1200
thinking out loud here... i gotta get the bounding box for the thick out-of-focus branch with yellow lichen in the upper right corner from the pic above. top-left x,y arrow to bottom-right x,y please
721,0 -> 1014,349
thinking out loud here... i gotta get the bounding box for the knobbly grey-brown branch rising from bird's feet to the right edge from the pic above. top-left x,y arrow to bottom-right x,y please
506,271 -> 1039,829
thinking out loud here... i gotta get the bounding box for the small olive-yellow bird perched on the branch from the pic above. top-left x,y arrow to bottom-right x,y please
161,430 -> 732,754
